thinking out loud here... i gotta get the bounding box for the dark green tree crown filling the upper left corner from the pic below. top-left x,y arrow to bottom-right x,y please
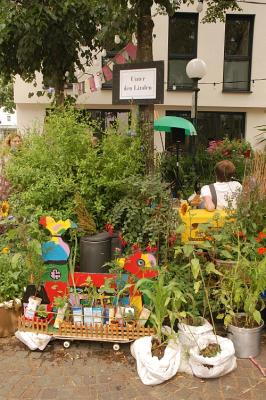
0,0 -> 103,103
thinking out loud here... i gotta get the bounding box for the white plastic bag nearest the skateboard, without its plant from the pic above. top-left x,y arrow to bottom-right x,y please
130,336 -> 181,385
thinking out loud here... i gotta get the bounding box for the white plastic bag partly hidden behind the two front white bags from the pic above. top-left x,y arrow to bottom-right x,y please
178,318 -> 213,351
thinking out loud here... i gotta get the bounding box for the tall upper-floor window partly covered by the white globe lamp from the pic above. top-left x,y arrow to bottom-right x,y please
168,13 -> 198,90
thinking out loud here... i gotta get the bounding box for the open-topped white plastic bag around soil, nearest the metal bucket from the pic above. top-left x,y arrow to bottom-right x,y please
189,335 -> 236,378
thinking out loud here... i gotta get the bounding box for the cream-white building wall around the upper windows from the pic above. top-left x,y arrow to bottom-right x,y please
15,3 -> 266,149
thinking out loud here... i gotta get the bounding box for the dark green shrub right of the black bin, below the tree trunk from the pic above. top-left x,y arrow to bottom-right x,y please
111,175 -> 177,259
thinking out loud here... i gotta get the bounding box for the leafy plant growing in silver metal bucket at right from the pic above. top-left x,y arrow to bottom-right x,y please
214,255 -> 266,358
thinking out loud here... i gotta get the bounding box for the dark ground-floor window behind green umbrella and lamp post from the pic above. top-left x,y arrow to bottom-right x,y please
165,110 -> 246,148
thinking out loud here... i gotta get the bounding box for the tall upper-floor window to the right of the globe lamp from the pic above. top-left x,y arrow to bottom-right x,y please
223,15 -> 254,92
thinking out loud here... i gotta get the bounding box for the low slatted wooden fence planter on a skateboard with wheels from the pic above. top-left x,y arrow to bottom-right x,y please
18,316 -> 154,351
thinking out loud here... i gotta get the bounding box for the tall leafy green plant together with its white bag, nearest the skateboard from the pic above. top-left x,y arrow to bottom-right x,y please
131,271 -> 185,385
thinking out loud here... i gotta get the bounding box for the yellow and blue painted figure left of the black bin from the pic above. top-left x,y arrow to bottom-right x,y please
39,217 -> 77,263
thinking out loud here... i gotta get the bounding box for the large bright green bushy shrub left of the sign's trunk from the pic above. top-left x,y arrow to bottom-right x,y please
7,109 -> 142,228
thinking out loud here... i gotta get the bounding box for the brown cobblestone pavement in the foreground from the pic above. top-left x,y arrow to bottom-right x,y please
0,335 -> 266,400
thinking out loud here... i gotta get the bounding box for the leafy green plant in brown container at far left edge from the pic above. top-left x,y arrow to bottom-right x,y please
0,217 -> 46,336
